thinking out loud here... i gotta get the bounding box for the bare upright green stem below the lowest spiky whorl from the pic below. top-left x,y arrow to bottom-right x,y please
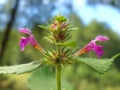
56,64 -> 61,90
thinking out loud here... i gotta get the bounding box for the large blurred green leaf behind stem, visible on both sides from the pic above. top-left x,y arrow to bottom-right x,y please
28,66 -> 73,90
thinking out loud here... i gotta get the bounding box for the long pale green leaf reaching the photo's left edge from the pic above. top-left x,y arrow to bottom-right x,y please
0,61 -> 42,74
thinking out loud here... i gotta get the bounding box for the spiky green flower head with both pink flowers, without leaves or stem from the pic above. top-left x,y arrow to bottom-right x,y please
19,16 -> 109,65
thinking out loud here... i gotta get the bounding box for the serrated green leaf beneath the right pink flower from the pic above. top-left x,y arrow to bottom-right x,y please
76,58 -> 113,74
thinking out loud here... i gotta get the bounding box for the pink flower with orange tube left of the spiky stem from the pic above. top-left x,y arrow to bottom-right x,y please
19,28 -> 44,52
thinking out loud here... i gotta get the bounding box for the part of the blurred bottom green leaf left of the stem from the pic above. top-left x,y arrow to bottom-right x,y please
28,66 -> 56,90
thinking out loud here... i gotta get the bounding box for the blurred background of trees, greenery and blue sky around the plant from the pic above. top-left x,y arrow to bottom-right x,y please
0,0 -> 120,90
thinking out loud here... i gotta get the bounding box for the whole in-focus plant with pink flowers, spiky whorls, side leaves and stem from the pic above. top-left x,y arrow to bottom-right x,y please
0,15 -> 118,90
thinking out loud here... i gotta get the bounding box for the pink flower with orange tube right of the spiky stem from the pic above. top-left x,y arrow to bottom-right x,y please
74,35 -> 109,58
